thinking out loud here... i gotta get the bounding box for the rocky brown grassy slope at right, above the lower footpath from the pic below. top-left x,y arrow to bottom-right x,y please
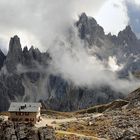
56,89 -> 140,140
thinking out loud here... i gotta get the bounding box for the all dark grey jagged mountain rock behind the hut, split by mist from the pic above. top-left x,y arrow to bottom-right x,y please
0,13 -> 140,111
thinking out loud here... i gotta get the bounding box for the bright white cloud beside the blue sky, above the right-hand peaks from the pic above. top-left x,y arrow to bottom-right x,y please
95,0 -> 128,35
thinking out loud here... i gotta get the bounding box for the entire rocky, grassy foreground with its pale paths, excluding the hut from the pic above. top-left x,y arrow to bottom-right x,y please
0,89 -> 140,140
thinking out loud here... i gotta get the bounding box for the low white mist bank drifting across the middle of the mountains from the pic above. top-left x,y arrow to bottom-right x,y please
49,28 -> 140,93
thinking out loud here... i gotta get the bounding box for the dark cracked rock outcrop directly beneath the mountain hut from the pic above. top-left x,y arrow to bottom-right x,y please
0,121 -> 56,140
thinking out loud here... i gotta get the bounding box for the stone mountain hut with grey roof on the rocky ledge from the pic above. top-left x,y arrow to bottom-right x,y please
8,102 -> 41,124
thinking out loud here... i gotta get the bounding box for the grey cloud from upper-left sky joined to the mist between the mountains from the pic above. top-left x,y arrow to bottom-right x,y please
0,0 -> 139,96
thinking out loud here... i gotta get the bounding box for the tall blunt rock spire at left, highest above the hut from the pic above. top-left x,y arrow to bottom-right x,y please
5,35 -> 23,72
